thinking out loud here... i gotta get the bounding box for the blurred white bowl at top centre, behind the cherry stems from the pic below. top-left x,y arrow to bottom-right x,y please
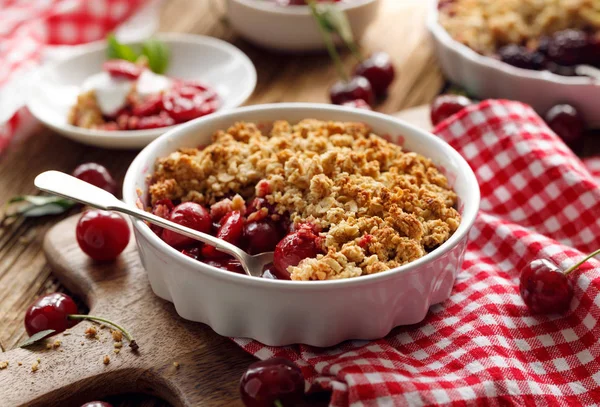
227,0 -> 379,51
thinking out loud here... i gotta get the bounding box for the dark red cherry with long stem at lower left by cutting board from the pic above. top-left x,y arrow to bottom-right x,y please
25,293 -> 78,336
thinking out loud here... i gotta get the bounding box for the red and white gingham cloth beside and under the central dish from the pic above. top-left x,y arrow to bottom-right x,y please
235,100 -> 600,407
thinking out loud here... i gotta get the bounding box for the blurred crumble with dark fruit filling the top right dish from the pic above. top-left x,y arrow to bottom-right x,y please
438,0 -> 600,76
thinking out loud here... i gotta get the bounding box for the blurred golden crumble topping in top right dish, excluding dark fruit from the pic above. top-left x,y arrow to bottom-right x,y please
439,0 -> 600,55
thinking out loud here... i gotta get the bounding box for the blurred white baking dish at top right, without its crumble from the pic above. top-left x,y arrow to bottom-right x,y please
427,0 -> 600,126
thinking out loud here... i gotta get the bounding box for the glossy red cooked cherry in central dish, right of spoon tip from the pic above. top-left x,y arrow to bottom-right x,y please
271,228 -> 319,280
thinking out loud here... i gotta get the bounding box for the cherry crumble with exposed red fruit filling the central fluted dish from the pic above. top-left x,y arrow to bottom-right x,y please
148,119 -> 460,280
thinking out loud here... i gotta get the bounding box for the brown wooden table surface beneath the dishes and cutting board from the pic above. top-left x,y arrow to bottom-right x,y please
0,0 -> 444,406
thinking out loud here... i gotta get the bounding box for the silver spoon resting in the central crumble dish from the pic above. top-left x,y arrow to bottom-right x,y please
34,171 -> 273,277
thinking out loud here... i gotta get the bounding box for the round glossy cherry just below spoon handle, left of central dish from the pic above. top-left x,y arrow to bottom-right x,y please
75,209 -> 130,261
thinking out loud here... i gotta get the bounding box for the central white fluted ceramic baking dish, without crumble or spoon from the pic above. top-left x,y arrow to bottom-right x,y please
123,103 -> 479,346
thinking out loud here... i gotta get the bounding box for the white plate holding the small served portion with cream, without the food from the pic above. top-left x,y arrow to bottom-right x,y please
27,34 -> 256,149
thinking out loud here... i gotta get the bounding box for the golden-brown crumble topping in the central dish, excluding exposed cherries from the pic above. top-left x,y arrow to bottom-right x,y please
149,119 -> 460,280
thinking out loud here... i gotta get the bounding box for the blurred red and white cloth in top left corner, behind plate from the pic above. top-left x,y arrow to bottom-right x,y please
0,0 -> 152,153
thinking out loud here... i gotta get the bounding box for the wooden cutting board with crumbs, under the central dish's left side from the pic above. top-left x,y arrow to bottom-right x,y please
0,108 -> 430,407
